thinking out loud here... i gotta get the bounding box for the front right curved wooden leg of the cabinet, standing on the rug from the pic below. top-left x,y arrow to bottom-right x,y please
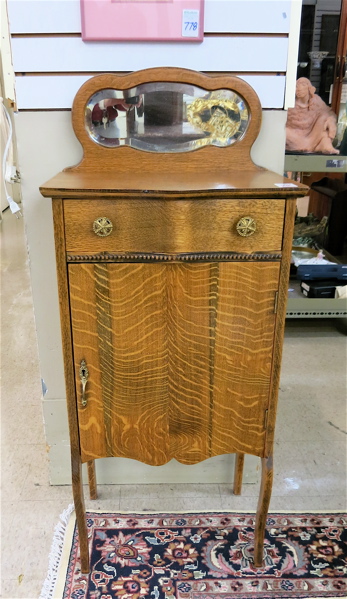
254,455 -> 273,568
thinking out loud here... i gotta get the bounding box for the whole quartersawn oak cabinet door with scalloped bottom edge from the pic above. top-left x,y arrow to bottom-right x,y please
69,262 -> 279,465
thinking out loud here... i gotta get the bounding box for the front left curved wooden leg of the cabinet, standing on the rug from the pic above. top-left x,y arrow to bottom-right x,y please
71,456 -> 89,574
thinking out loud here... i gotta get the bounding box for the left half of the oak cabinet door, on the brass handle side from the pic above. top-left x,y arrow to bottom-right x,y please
69,264 -> 169,465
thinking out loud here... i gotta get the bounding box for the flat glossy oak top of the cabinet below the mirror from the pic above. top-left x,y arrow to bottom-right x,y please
40,169 -> 308,199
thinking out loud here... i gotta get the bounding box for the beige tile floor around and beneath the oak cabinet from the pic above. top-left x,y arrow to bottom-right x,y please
1,211 -> 347,599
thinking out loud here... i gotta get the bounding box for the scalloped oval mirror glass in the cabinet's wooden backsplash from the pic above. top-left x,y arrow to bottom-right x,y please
85,82 -> 250,152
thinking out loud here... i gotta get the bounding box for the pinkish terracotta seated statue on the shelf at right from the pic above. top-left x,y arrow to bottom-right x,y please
286,77 -> 339,154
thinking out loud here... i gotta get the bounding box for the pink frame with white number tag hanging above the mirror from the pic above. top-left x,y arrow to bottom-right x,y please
81,0 -> 204,42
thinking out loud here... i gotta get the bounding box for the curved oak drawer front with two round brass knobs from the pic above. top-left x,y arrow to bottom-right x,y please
64,199 -> 285,254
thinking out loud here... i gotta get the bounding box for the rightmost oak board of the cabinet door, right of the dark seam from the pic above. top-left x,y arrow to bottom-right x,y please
212,263 -> 280,455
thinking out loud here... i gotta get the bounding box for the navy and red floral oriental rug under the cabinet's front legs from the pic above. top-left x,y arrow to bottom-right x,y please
41,512 -> 347,599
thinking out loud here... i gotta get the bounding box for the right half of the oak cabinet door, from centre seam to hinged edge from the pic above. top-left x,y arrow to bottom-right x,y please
168,262 -> 280,464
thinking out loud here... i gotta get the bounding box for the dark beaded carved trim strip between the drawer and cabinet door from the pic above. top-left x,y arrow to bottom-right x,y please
67,252 -> 282,263
